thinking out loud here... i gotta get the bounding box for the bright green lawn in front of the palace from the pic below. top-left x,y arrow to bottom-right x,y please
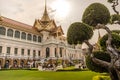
0,70 -> 99,80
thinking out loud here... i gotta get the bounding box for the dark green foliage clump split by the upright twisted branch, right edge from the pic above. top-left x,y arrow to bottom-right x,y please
100,32 -> 120,51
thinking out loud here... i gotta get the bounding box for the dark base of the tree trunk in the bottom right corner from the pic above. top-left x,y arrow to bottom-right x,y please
109,67 -> 120,80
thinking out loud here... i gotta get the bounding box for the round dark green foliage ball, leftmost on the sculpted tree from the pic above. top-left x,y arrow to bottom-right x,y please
67,22 -> 93,44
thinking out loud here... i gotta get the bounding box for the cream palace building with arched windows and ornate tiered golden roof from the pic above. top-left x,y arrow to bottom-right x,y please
0,2 -> 84,67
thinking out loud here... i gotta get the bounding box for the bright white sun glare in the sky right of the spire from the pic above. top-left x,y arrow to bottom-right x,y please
51,0 -> 70,18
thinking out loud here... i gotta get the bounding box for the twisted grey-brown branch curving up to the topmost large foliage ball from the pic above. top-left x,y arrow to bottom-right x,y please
96,24 -> 120,67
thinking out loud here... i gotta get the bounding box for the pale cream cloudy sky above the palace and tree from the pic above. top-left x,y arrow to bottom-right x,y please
0,0 -> 120,45
